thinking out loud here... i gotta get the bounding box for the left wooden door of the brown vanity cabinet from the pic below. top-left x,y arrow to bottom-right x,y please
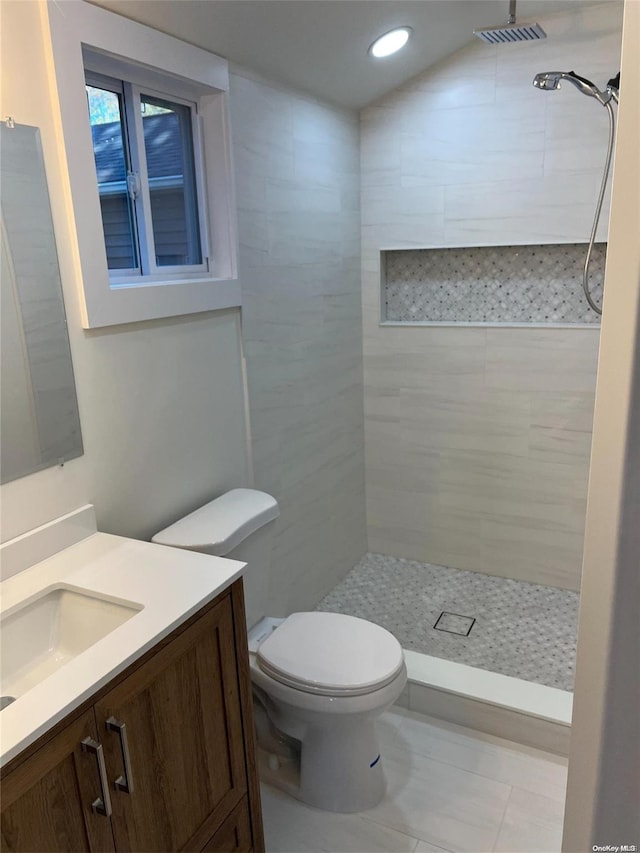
2,711 -> 114,853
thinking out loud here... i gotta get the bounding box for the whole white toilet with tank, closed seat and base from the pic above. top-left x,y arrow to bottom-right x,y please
152,489 -> 407,812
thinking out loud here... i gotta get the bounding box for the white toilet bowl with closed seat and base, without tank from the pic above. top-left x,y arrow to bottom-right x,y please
249,612 -> 407,812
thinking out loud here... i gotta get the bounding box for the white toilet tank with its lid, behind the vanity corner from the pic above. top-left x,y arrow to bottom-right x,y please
151,489 -> 280,628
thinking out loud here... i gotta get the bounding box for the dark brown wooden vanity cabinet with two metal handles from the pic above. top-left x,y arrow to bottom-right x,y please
2,581 -> 264,853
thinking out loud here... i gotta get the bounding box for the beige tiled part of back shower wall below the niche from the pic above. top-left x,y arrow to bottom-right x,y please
365,327 -> 598,589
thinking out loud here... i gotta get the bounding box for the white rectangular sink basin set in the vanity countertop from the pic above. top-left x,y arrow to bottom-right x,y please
0,584 -> 142,699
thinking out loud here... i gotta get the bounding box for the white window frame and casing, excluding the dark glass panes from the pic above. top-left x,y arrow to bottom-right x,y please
46,0 -> 241,328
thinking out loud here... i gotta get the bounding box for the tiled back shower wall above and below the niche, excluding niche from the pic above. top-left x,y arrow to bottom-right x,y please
361,3 -> 622,589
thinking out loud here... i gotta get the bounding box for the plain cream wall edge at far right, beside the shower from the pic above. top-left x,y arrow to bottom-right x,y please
562,0 -> 640,853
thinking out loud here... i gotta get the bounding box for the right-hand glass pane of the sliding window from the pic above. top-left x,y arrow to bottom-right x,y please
140,95 -> 202,266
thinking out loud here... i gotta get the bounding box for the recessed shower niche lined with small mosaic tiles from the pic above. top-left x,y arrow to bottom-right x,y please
381,243 -> 606,326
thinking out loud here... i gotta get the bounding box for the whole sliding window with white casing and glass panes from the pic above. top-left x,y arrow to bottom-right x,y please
43,0 -> 241,328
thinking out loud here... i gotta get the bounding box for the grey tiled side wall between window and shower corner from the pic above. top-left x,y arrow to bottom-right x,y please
231,69 -> 366,615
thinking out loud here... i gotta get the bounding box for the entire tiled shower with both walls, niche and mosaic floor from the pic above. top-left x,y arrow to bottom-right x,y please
232,4 -> 621,704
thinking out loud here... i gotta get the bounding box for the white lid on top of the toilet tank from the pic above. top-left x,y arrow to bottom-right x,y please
151,489 -> 280,557
